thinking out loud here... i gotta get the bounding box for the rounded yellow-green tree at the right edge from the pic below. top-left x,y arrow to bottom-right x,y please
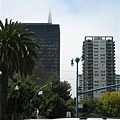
97,92 -> 120,117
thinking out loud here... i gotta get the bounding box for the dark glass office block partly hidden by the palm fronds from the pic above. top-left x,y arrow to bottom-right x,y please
22,23 -> 60,80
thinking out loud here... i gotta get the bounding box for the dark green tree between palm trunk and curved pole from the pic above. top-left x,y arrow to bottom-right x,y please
6,80 -> 41,120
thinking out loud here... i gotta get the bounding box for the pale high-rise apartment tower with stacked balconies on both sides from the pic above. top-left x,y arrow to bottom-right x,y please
82,36 -> 115,98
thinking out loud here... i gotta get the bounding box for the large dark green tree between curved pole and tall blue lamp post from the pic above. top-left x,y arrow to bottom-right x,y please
39,76 -> 74,119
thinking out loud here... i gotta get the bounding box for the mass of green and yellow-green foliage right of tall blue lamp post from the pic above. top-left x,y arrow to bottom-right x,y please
79,92 -> 120,117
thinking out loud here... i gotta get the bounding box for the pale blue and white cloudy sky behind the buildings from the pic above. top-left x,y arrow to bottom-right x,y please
0,0 -> 120,97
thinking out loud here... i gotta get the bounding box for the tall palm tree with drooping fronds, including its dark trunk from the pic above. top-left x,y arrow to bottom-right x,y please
0,19 -> 39,120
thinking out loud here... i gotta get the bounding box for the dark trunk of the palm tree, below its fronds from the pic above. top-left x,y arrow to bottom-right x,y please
1,66 -> 8,120
